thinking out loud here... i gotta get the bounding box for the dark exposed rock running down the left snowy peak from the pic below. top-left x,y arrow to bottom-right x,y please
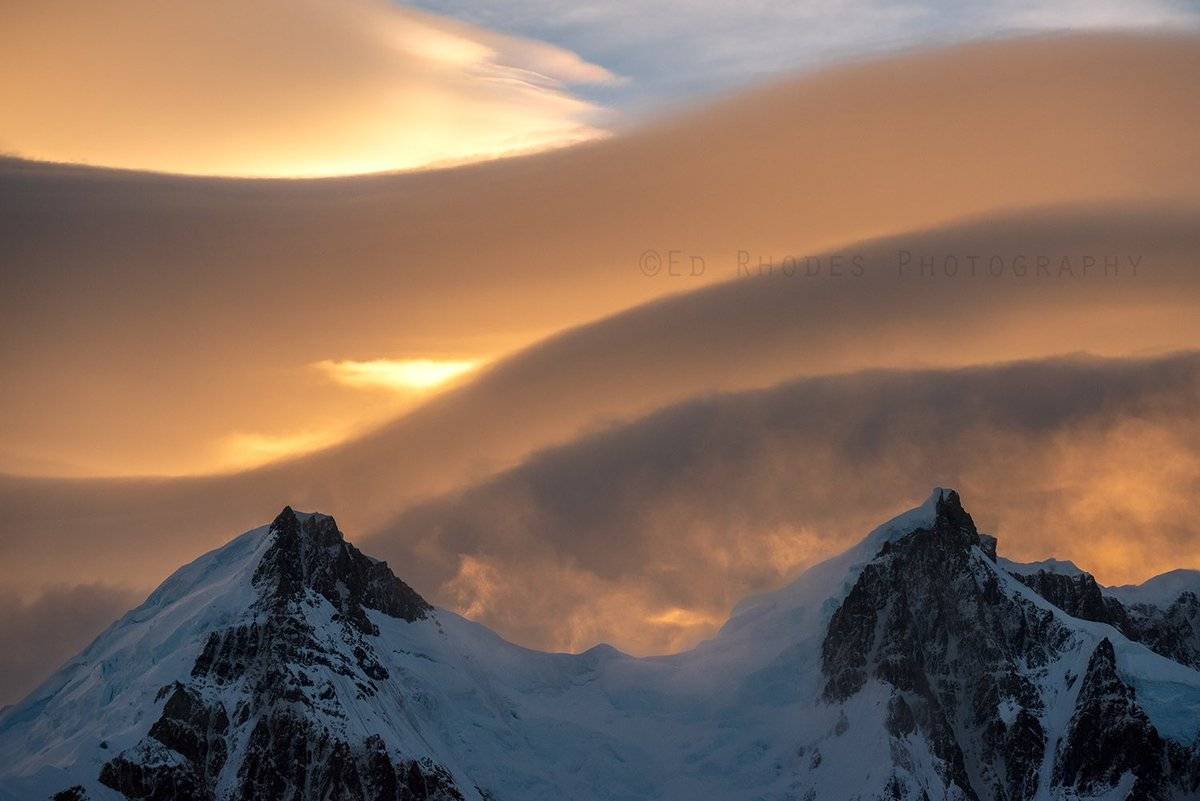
100,507 -> 462,801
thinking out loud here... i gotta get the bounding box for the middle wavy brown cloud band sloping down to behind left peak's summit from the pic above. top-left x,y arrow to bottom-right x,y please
0,205 -> 1200,613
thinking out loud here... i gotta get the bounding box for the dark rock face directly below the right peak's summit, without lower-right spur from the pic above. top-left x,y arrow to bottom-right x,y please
822,492 -> 1068,801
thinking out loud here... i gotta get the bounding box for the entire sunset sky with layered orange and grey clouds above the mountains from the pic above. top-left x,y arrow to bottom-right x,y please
0,6 -> 1200,703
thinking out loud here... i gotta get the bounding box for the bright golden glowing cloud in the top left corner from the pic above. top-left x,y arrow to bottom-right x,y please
0,0 -> 613,175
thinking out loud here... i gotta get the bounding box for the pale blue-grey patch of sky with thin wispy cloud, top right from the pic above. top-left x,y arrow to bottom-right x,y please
416,0 -> 1200,108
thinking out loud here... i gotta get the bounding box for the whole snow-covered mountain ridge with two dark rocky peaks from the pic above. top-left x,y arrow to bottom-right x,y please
0,489 -> 1200,801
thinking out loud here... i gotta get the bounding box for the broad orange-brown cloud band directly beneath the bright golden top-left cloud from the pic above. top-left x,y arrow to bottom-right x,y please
0,37 -> 1200,476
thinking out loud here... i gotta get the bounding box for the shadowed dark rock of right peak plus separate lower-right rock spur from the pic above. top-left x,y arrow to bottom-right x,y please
822,493 -> 1200,799
